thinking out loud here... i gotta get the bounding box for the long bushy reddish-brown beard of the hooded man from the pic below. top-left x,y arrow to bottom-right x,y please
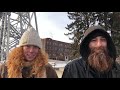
88,47 -> 113,72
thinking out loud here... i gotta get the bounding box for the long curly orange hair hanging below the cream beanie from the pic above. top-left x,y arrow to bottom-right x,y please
7,47 -> 48,78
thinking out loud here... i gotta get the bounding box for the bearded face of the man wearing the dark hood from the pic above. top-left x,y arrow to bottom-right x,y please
88,36 -> 112,72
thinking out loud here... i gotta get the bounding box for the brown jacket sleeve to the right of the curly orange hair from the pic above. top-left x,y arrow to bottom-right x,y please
46,64 -> 58,78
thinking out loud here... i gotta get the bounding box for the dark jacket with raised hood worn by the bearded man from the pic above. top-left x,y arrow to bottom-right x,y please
62,26 -> 120,78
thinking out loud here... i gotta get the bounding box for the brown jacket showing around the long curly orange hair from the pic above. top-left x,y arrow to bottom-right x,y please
0,64 -> 58,78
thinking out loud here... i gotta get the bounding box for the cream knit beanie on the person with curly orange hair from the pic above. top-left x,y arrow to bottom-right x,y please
18,27 -> 42,48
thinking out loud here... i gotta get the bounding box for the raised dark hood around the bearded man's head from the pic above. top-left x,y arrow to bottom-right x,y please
80,26 -> 116,60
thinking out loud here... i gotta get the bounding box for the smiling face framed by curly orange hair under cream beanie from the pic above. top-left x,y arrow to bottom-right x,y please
23,45 -> 39,61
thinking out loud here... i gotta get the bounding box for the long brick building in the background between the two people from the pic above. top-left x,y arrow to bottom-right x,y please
41,38 -> 71,61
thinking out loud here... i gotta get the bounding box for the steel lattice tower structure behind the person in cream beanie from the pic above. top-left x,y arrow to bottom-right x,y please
0,12 -> 38,61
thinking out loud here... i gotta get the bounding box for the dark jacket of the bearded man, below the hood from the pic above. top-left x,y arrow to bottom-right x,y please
62,58 -> 120,78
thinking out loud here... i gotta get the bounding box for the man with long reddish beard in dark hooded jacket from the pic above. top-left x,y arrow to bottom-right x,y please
62,26 -> 120,78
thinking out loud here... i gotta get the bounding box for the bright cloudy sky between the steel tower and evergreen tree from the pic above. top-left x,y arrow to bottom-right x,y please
36,12 -> 71,43
